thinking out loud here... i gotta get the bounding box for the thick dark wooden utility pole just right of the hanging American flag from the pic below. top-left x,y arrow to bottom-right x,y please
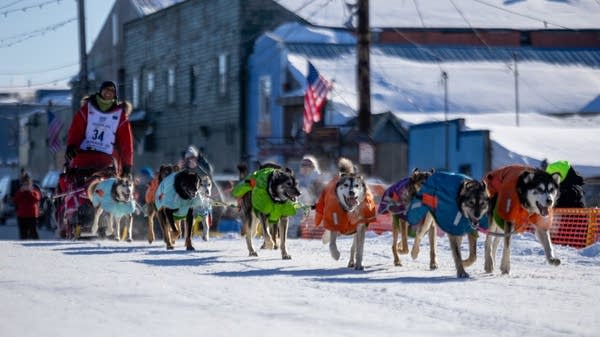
356,0 -> 375,175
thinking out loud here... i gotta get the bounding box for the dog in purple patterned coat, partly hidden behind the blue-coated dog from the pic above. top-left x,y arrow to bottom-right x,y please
377,169 -> 433,266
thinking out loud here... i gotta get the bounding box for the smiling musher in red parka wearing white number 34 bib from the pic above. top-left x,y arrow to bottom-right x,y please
65,81 -> 133,177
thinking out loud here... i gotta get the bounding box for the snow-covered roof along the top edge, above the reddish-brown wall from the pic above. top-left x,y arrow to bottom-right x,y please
275,0 -> 600,29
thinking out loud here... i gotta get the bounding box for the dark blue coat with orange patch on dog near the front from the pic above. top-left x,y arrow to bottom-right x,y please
406,172 -> 488,236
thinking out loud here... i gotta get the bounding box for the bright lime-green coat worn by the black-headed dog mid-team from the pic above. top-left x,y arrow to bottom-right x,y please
231,167 -> 300,223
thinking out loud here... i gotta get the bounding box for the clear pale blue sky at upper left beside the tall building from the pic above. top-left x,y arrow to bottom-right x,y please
0,0 -> 115,92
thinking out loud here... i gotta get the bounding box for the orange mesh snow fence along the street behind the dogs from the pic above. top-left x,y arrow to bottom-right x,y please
300,208 -> 600,248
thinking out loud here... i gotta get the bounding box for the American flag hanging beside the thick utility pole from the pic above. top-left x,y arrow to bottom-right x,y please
302,62 -> 331,133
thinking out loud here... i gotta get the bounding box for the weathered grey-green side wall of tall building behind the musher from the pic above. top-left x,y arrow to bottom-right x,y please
124,0 -> 300,171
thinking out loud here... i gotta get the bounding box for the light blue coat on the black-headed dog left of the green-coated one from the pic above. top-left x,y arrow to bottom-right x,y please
154,172 -> 207,218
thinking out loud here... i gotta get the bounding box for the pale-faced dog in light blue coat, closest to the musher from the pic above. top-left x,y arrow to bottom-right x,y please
87,178 -> 135,242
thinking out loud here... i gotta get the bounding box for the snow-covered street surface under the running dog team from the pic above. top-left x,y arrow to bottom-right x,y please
0,220 -> 600,337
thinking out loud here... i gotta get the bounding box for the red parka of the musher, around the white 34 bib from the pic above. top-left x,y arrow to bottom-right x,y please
67,94 -> 133,169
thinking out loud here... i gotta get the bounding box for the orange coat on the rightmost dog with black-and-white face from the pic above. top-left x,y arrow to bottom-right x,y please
484,165 -> 552,233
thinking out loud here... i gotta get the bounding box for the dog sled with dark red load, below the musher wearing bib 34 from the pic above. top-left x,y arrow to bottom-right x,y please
53,167 -> 116,240
